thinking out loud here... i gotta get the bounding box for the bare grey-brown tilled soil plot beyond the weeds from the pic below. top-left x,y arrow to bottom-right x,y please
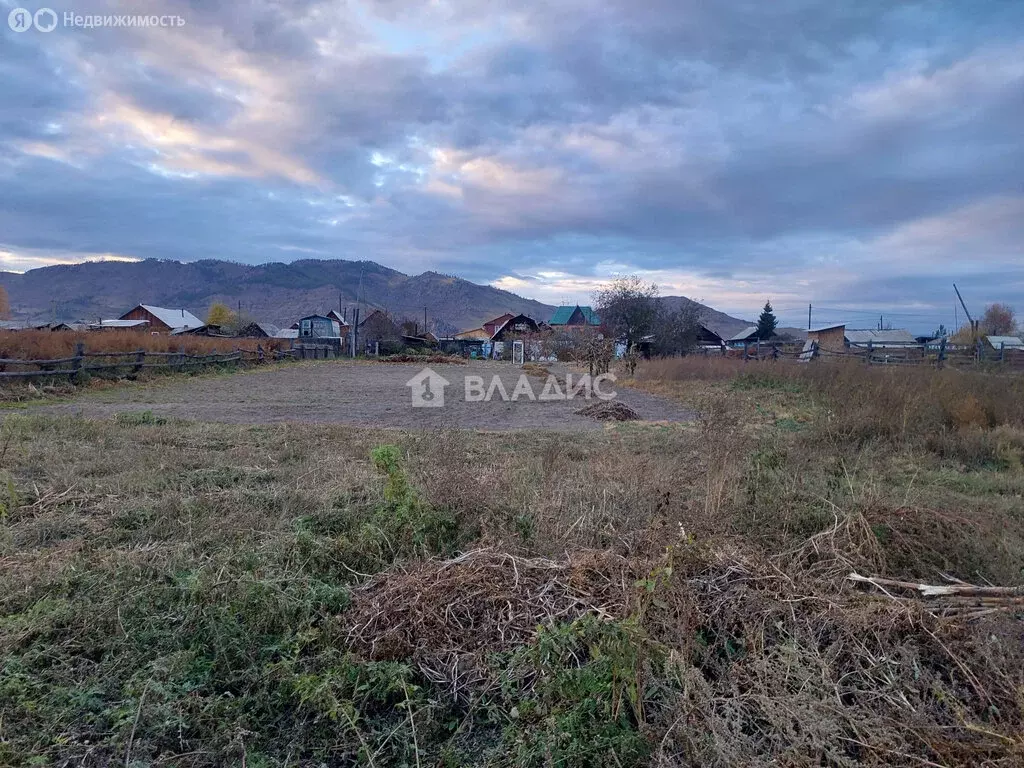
25,360 -> 692,430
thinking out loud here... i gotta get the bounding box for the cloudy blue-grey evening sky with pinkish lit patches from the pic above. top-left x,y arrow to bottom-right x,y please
0,0 -> 1024,332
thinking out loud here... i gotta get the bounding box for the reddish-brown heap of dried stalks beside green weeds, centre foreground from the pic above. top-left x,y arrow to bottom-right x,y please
344,549 -> 645,696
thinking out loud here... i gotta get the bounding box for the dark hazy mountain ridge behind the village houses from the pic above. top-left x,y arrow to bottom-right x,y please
0,259 -> 765,335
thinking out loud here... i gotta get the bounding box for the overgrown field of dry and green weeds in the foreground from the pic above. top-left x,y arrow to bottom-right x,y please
0,359 -> 1024,767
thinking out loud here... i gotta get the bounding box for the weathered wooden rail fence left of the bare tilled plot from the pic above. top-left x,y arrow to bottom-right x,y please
0,344 -> 296,379
